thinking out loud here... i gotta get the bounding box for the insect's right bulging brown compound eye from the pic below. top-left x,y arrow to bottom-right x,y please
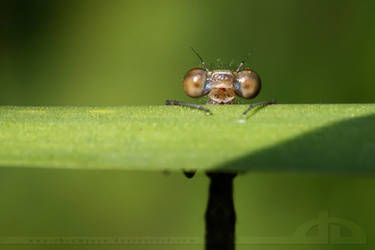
234,69 -> 262,99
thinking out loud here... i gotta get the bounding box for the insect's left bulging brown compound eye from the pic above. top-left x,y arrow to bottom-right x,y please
184,68 -> 208,97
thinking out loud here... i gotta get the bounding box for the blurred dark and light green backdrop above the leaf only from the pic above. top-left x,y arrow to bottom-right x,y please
0,0 -> 375,106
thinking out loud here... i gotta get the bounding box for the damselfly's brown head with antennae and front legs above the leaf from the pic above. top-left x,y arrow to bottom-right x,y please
166,48 -> 276,115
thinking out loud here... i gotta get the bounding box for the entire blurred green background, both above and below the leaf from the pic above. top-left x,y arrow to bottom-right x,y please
0,0 -> 375,250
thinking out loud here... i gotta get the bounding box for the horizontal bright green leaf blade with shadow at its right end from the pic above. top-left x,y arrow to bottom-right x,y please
0,104 -> 375,172
